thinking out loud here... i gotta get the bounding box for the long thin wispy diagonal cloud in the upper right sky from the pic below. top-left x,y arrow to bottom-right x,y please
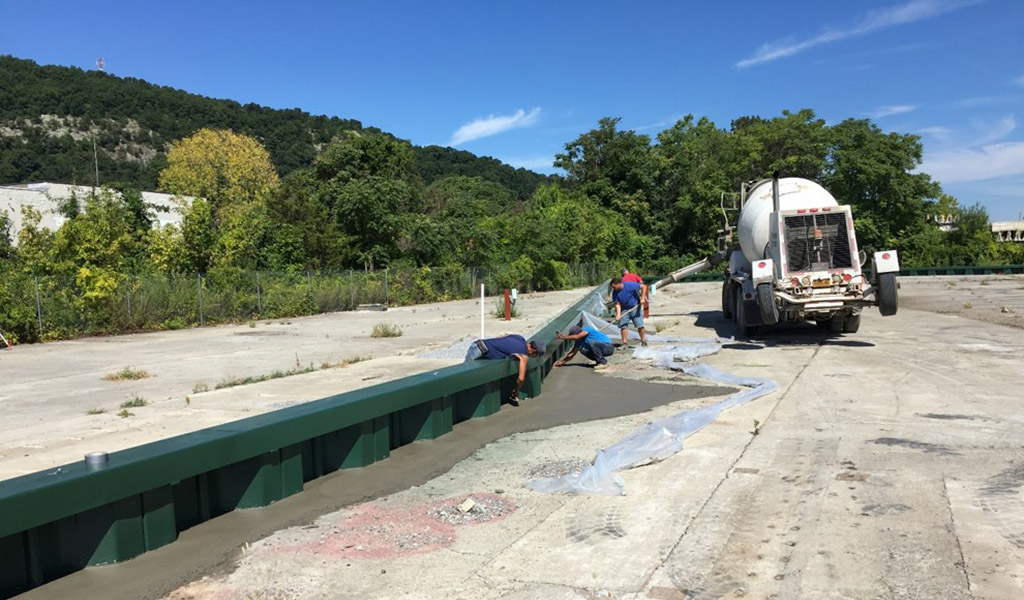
736,0 -> 981,69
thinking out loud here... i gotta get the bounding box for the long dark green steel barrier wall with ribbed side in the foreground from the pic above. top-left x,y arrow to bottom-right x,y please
0,283 -> 607,598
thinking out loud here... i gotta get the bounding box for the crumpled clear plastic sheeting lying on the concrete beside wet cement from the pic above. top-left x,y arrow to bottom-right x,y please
526,313 -> 777,496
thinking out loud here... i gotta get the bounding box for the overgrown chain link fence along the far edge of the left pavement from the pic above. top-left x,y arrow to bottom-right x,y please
0,263 -> 615,343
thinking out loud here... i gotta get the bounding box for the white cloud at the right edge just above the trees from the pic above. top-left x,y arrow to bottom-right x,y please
919,141 -> 1024,183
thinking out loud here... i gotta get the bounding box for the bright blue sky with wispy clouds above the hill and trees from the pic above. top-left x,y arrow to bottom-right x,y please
0,0 -> 1024,220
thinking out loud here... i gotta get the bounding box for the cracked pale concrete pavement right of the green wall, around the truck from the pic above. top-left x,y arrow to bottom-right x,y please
14,280 -> 1024,600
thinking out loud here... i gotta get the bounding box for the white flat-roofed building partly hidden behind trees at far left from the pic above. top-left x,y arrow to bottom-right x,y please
0,182 -> 191,244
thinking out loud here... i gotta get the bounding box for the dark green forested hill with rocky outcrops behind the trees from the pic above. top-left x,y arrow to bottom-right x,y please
0,56 -> 547,198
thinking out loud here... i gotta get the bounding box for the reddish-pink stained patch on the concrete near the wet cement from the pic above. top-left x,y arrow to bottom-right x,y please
279,494 -> 516,559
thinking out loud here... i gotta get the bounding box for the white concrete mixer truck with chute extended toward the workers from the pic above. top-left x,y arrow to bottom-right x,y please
654,173 -> 899,337
